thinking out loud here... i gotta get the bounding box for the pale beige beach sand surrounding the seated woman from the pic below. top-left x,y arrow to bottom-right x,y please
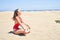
0,11 -> 60,40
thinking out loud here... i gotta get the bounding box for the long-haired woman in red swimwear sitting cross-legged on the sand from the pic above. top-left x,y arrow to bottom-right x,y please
13,9 -> 30,34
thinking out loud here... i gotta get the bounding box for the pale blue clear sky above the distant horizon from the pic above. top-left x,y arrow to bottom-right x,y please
0,0 -> 60,10
